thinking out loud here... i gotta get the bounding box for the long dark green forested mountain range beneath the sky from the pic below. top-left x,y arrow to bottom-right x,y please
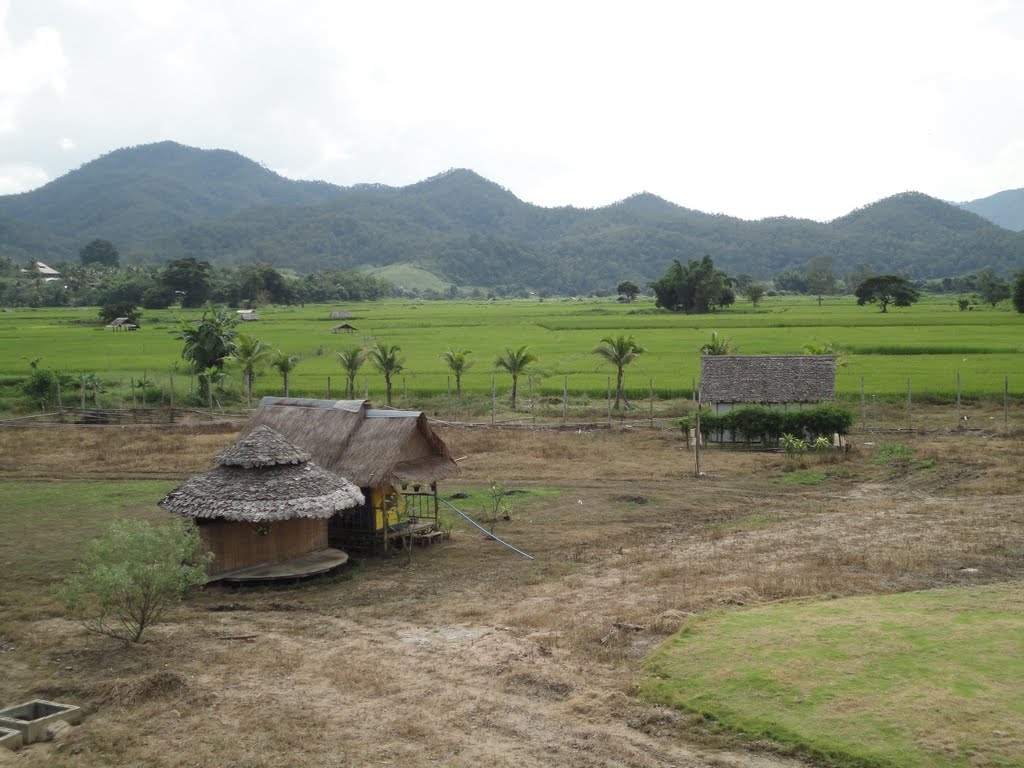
0,142 -> 1024,293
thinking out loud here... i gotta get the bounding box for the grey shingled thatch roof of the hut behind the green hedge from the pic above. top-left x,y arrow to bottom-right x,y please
700,354 -> 836,403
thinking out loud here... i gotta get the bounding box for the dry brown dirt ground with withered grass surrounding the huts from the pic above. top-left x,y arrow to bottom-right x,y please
0,429 -> 1024,768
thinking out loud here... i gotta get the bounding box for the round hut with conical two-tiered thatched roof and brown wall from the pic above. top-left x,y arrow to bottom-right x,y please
160,426 -> 364,581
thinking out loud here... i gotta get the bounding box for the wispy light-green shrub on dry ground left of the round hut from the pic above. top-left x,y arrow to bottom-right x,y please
57,519 -> 210,643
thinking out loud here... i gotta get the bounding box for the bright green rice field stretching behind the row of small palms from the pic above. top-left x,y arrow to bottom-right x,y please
0,290 -> 1024,407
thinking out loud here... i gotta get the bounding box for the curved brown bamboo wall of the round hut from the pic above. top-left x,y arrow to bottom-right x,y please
200,517 -> 328,577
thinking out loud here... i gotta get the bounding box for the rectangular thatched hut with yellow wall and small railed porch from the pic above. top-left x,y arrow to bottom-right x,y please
243,397 -> 459,549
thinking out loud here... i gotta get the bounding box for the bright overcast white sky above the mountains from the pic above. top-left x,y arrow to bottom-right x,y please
0,0 -> 1024,221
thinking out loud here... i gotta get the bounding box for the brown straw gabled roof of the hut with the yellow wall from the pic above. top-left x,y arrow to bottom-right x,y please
243,397 -> 459,487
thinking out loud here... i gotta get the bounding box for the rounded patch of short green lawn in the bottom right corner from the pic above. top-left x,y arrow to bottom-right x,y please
642,582 -> 1024,768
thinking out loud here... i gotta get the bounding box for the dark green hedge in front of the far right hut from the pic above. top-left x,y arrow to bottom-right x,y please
700,406 -> 853,444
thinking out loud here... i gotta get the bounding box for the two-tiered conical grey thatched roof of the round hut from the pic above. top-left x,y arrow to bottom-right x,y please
160,427 -> 364,522
